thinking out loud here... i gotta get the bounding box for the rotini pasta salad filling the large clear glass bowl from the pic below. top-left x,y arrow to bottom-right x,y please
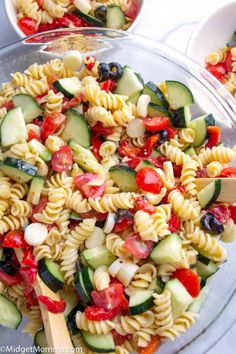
0,51 -> 236,354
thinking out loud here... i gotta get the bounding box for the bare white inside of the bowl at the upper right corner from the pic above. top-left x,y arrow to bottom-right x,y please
186,1 -> 236,66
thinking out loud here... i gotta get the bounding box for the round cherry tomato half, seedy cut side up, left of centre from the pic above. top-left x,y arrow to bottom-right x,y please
51,146 -> 74,173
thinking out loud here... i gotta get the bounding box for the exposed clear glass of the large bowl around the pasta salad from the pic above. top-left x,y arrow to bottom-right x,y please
0,28 -> 236,354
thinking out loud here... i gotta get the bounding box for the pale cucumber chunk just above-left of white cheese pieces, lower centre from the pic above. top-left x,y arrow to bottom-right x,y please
82,246 -> 116,269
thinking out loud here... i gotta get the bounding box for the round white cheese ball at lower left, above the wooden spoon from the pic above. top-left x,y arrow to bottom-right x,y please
24,222 -> 48,246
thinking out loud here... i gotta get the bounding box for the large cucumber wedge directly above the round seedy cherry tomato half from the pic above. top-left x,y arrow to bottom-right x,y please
62,108 -> 90,148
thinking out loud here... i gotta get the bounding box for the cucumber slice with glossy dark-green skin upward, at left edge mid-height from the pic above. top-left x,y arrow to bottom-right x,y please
0,157 -> 38,183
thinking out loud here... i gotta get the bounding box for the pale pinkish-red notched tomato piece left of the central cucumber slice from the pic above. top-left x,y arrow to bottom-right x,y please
74,173 -> 106,198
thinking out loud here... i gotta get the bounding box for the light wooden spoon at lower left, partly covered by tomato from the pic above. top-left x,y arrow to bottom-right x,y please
15,249 -> 74,354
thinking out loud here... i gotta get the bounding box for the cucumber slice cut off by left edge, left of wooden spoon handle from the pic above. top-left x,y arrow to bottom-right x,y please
0,295 -> 22,329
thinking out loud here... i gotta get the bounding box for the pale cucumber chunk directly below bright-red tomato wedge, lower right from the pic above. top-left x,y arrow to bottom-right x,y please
165,279 -> 193,319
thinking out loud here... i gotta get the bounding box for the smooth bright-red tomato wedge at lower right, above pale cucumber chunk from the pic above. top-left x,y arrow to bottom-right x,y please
172,268 -> 200,297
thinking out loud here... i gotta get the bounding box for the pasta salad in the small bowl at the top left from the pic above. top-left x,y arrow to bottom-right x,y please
15,0 -> 139,35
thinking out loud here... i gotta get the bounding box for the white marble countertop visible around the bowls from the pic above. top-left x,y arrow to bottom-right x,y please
0,0 -> 236,354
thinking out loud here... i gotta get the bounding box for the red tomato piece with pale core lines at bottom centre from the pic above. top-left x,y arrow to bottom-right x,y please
91,284 -> 123,310
